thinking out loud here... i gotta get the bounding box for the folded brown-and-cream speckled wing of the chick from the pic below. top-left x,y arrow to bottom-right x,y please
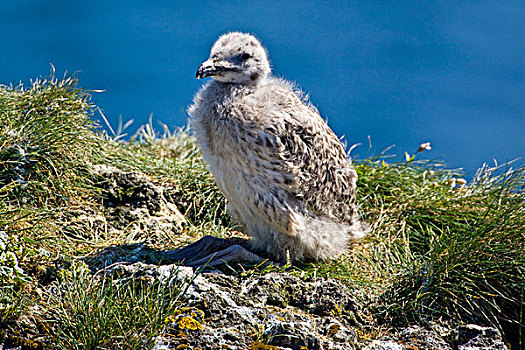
225,90 -> 357,233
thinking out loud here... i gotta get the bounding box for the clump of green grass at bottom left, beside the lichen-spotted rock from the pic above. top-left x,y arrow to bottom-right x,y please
38,264 -> 188,350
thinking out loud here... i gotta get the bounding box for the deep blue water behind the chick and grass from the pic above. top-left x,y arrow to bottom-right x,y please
0,0 -> 525,172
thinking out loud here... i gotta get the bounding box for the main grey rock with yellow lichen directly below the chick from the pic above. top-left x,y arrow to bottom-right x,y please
110,262 -> 362,350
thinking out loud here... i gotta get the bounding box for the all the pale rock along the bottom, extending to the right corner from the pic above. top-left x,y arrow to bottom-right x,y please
95,254 -> 507,350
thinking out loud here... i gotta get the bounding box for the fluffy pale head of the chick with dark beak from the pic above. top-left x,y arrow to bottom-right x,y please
196,32 -> 270,84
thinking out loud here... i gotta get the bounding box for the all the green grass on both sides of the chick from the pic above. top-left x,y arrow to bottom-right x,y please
0,76 -> 525,349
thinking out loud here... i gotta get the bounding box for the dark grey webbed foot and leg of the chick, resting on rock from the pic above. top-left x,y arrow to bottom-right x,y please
160,236 -> 264,267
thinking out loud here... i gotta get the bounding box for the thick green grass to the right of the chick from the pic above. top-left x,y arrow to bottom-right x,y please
307,154 -> 525,339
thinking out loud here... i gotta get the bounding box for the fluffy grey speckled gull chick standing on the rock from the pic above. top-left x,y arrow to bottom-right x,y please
166,32 -> 366,266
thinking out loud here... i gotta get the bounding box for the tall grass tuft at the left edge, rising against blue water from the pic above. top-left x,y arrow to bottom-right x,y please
0,71 -> 101,208
